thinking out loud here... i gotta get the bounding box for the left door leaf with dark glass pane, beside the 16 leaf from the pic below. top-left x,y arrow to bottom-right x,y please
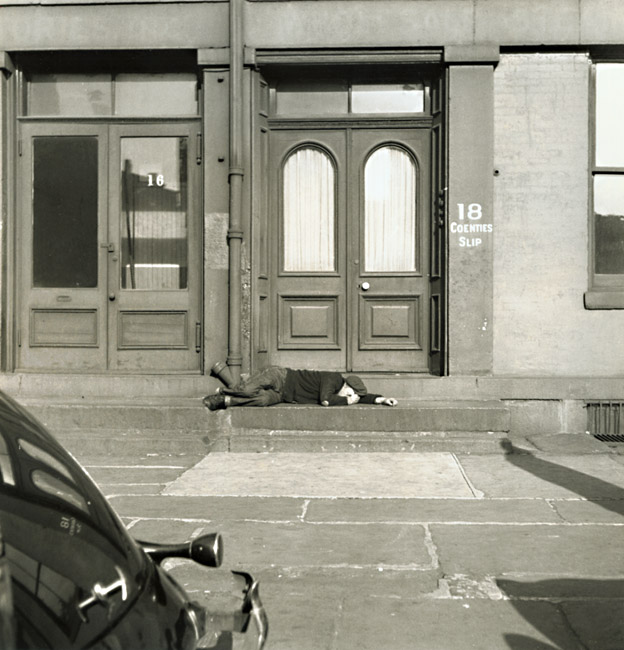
17,124 -> 107,371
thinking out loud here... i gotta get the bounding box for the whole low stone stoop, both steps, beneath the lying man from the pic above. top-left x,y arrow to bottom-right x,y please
21,398 -> 511,457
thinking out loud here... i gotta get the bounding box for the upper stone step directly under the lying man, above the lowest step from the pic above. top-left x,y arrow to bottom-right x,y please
22,399 -> 510,432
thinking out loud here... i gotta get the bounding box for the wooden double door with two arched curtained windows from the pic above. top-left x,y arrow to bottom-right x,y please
269,127 -> 441,372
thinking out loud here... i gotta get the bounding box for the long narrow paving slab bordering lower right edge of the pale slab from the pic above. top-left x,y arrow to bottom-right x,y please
305,498 -> 562,523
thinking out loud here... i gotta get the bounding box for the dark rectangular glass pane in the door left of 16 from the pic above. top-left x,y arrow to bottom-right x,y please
33,136 -> 98,288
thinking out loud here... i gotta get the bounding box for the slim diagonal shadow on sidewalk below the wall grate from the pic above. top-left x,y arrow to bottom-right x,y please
501,440 -> 624,516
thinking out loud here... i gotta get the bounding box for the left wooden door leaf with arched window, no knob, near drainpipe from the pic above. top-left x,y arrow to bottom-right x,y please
270,130 -> 346,370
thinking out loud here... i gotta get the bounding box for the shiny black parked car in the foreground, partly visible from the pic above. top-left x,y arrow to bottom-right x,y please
0,392 -> 268,650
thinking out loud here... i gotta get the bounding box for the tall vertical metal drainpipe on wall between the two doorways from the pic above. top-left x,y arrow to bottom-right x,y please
227,0 -> 245,383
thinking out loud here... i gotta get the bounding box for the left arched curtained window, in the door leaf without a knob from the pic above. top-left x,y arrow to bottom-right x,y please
283,147 -> 336,273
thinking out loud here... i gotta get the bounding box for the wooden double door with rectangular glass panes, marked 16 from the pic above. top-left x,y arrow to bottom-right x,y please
16,121 -> 201,372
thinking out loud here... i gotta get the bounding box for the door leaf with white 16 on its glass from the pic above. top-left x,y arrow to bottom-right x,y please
108,124 -> 201,370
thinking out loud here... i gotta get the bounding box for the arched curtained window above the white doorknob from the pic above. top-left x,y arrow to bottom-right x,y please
364,146 -> 418,273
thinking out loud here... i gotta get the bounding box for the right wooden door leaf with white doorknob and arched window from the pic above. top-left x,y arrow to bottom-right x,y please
354,129 -> 430,372
